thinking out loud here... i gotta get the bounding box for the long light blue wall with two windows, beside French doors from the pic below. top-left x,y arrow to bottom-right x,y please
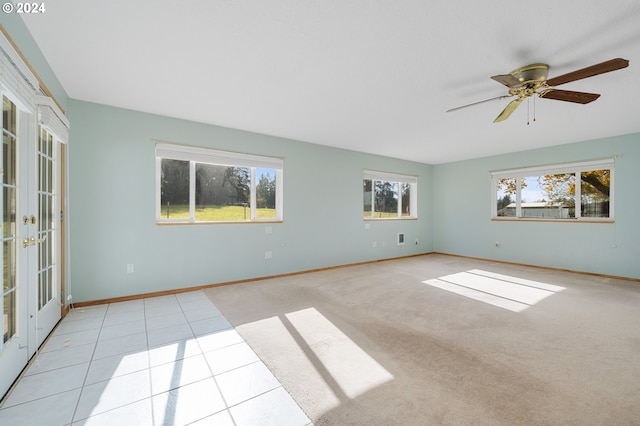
68,100 -> 433,302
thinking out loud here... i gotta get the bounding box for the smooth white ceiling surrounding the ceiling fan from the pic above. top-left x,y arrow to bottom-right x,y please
21,0 -> 640,164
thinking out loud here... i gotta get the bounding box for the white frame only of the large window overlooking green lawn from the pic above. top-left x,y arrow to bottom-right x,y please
153,141 -> 284,224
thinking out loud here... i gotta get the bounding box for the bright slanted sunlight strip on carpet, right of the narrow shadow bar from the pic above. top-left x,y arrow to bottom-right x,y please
285,308 -> 393,398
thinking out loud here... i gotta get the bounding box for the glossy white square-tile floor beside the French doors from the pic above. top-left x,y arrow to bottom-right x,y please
0,291 -> 311,426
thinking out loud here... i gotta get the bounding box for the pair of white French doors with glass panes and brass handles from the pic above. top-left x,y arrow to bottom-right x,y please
0,94 -> 62,397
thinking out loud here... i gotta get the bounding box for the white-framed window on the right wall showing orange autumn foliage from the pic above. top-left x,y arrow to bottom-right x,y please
491,159 -> 614,221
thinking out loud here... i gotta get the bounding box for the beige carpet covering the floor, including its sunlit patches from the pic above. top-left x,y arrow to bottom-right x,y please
206,255 -> 640,426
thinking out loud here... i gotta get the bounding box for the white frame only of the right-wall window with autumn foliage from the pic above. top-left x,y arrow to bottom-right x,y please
491,158 -> 615,222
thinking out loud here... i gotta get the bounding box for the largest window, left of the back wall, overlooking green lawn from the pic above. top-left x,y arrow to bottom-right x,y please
156,142 -> 283,223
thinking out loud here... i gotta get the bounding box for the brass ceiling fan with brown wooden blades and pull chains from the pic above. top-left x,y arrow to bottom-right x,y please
447,58 -> 629,123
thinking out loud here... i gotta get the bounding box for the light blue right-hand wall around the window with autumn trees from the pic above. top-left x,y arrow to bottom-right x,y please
433,133 -> 640,278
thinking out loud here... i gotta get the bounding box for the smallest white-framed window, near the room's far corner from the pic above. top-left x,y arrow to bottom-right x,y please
362,170 -> 418,219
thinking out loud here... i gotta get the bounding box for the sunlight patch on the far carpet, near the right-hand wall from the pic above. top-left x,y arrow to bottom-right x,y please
423,269 -> 564,312
